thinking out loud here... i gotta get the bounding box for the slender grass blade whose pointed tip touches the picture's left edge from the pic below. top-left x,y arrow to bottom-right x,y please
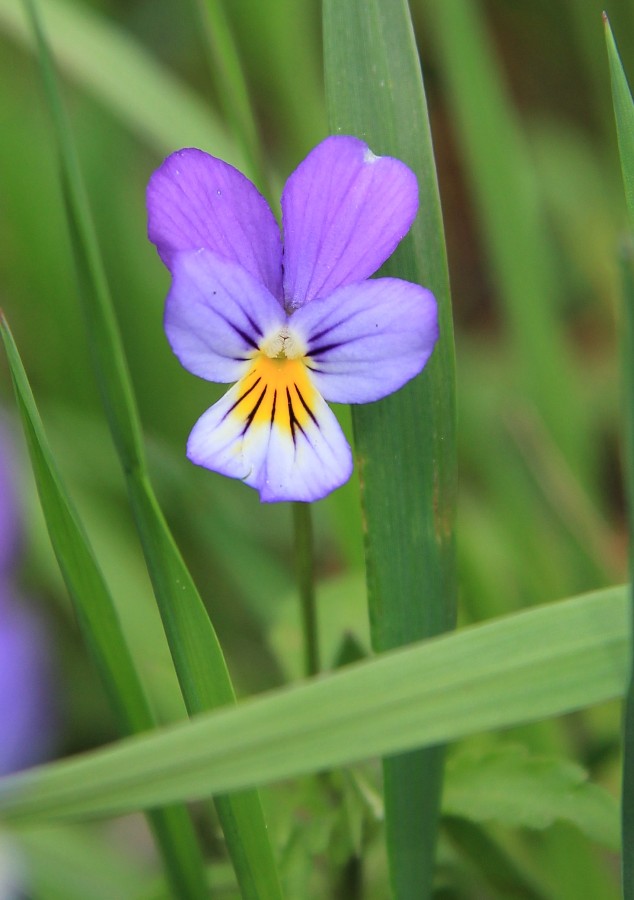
0,318 -> 205,898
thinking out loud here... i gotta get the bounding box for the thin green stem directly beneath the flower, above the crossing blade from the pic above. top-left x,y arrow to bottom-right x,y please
293,503 -> 319,678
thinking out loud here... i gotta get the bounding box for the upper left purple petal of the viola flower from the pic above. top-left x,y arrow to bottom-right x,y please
147,149 -> 282,299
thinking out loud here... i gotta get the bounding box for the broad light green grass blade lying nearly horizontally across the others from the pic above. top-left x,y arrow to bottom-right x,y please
0,587 -> 629,822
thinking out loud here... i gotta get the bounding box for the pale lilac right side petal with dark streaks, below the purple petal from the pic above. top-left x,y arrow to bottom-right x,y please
290,278 -> 438,403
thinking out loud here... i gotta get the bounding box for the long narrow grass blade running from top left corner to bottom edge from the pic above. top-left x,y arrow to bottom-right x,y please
27,2 -> 280,900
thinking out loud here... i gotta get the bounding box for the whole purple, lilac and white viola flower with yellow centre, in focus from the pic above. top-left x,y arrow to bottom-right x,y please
147,136 -> 438,502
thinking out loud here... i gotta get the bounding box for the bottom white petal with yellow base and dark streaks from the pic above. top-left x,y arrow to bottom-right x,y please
187,368 -> 352,503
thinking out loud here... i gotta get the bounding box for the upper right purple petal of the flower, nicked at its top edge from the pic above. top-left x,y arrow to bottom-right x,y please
282,135 -> 418,309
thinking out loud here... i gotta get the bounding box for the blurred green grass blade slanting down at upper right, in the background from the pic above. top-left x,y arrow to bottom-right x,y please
425,0 -> 595,488
